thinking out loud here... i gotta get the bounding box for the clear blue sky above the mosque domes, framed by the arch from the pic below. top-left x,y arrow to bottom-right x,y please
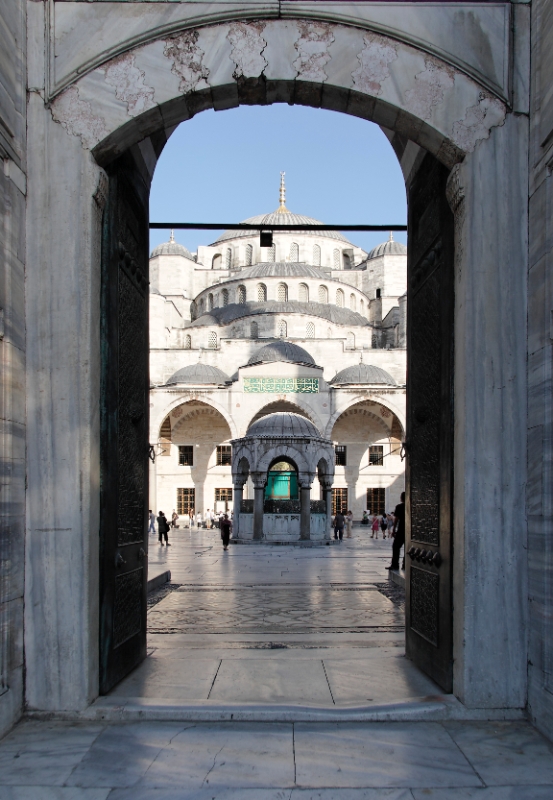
150,105 -> 407,251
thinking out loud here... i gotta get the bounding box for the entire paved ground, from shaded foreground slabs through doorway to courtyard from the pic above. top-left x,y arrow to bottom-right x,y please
0,527 -> 553,800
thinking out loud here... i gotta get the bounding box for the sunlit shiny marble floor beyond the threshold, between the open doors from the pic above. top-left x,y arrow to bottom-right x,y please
111,526 -> 426,707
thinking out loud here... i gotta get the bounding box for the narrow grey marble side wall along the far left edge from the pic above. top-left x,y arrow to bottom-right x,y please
0,0 -> 27,736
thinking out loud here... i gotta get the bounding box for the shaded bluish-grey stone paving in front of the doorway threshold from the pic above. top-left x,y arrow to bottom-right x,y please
0,721 -> 553,800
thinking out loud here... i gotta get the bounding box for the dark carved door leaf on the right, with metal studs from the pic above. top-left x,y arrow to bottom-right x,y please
405,154 -> 454,692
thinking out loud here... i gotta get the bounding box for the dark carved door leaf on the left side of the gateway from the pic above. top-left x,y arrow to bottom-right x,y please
100,157 -> 149,694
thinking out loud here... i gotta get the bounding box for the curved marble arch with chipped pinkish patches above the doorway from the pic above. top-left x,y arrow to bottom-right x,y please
51,20 -> 506,169
